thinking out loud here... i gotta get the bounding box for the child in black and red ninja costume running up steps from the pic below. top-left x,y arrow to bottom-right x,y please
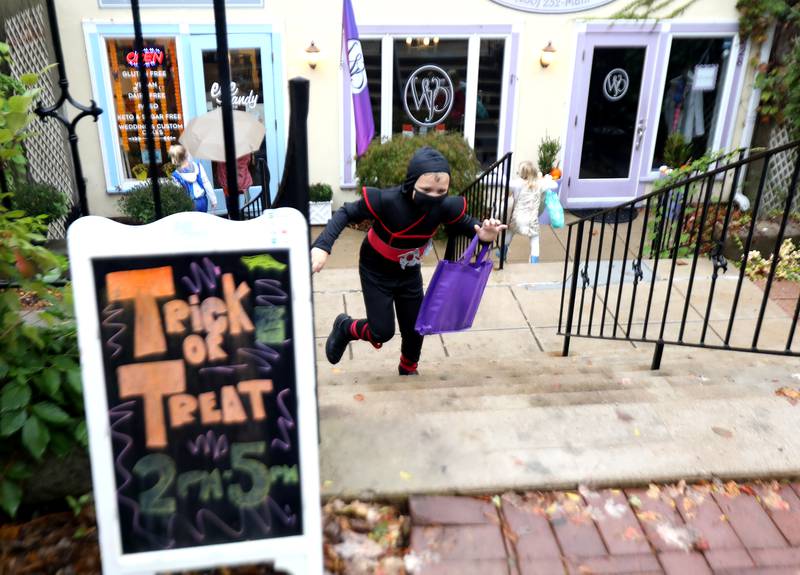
311,147 -> 506,375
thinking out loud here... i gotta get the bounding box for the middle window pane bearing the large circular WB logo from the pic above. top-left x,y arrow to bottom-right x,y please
392,37 -> 467,135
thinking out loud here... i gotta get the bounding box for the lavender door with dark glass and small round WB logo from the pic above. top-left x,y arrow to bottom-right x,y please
561,33 -> 657,208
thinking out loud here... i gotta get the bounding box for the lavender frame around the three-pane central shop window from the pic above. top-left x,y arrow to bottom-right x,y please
341,24 -> 519,187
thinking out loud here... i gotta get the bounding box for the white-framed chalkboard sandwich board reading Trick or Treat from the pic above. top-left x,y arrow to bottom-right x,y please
68,208 -> 322,575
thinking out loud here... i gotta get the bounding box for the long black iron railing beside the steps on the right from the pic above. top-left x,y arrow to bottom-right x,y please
558,141 -> 800,369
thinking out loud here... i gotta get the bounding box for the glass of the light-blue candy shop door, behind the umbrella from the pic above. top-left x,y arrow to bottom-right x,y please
203,47 -> 264,188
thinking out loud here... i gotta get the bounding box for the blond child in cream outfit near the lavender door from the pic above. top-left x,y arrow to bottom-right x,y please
503,161 -> 542,264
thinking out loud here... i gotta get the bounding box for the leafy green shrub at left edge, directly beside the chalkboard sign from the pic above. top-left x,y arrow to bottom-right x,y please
0,198 -> 87,516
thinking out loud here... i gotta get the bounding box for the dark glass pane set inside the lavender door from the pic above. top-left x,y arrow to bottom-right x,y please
580,47 -> 646,179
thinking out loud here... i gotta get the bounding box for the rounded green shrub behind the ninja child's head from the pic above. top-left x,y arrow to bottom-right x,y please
356,132 -> 481,194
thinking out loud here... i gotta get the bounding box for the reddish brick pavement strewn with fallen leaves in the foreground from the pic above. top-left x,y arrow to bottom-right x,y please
409,482 -> 800,575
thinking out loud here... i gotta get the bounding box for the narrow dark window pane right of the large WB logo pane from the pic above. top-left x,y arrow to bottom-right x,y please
475,40 -> 506,167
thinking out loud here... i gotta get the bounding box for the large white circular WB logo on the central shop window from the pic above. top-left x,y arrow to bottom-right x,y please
403,64 -> 454,127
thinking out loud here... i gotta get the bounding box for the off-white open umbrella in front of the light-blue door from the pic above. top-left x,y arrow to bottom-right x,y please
178,108 -> 265,162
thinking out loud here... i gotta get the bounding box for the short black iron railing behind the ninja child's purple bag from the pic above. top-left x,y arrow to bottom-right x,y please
444,152 -> 511,269
